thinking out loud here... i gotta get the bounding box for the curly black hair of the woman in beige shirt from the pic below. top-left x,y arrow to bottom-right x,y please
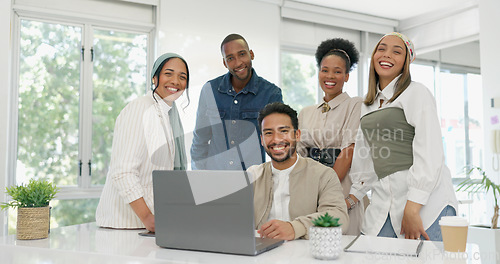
315,38 -> 359,73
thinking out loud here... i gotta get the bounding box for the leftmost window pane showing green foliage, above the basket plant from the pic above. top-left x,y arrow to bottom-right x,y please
17,20 -> 81,186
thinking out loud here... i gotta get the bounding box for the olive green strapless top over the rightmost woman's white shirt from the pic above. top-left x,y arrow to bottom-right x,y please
361,107 -> 415,179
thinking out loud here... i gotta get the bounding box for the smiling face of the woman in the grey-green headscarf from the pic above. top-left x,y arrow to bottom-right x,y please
153,58 -> 187,105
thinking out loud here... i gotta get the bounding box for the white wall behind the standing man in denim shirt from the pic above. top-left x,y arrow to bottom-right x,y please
157,0 -> 280,134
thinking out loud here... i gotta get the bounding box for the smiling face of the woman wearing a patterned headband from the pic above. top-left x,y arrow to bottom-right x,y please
372,35 -> 406,89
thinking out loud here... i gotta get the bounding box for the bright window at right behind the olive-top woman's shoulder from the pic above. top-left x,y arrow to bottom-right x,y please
411,63 -> 484,224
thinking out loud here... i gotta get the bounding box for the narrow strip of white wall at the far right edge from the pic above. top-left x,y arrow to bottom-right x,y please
479,0 -> 500,184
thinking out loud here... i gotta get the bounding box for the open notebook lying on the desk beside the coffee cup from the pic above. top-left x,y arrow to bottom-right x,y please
344,235 -> 424,257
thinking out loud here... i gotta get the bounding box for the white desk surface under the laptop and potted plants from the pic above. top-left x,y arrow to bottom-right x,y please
0,223 -> 481,264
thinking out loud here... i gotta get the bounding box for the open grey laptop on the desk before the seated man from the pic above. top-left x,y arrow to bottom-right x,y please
153,170 -> 283,256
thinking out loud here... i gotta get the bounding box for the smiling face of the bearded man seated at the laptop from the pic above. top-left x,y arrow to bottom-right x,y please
261,113 -> 300,170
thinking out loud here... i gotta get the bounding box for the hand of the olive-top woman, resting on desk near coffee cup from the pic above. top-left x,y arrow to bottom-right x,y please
401,201 -> 430,240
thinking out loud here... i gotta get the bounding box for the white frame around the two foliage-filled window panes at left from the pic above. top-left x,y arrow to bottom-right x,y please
7,3 -> 159,200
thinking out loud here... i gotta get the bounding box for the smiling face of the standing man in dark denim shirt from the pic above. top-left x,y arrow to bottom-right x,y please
222,39 -> 254,84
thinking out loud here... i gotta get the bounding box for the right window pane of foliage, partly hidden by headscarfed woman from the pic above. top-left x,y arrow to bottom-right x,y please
89,29 -> 149,185
